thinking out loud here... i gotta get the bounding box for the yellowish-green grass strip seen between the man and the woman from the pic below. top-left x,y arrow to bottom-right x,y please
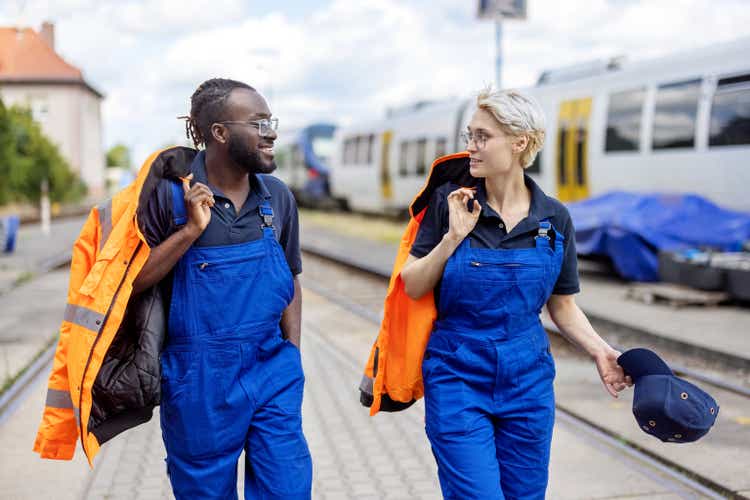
300,209 -> 407,243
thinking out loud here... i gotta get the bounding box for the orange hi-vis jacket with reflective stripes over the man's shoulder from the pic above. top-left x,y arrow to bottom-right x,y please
34,147 -> 197,466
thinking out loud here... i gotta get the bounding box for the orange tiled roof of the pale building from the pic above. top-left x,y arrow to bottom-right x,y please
0,27 -> 103,97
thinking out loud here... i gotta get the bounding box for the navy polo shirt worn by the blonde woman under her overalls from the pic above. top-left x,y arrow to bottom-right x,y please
410,175 -> 580,298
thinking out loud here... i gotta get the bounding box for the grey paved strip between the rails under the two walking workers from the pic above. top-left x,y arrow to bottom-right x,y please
0,280 -> 736,500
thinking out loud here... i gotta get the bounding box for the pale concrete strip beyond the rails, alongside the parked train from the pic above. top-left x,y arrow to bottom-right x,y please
300,215 -> 750,372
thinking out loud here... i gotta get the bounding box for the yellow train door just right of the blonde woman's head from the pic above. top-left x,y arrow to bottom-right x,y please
555,97 -> 591,201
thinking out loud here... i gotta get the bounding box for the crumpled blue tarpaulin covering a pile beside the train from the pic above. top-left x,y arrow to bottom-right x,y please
568,191 -> 750,281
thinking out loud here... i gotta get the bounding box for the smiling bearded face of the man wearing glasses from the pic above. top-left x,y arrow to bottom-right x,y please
225,89 -> 276,174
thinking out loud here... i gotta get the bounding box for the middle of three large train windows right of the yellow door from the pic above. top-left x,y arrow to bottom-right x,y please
652,80 -> 701,149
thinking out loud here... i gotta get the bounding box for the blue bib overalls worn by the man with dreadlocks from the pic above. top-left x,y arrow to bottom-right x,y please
161,177 -> 312,499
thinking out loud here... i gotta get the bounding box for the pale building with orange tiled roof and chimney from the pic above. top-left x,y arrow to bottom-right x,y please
0,23 -> 105,199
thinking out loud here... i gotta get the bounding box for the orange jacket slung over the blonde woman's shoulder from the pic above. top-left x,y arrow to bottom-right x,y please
359,152 -> 477,415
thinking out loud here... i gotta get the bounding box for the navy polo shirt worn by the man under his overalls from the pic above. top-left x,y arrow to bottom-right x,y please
139,151 -> 302,275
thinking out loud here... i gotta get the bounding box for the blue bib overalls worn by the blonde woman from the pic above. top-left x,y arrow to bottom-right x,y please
422,221 -> 563,500
